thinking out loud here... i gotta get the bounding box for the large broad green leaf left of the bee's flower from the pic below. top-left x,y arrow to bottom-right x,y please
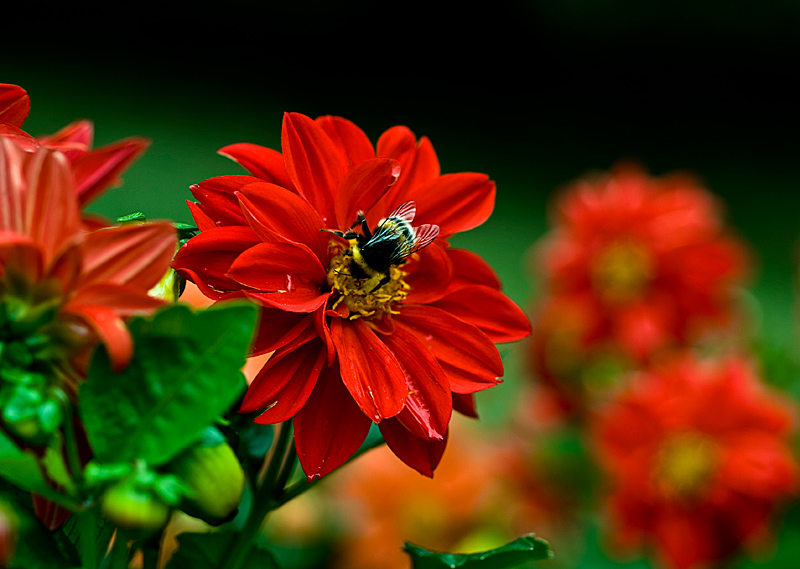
79,302 -> 256,466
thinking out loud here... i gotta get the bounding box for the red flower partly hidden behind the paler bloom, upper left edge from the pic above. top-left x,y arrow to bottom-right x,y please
0,84 -> 150,215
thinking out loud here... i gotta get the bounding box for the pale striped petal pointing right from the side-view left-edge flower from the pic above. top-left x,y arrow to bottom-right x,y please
81,223 -> 177,290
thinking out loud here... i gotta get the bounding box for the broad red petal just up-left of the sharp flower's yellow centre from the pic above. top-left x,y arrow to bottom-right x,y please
237,182 -> 330,264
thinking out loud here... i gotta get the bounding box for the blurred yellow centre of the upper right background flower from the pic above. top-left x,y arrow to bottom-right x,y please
590,241 -> 655,303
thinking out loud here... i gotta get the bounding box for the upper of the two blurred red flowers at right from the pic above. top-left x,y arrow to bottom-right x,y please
538,162 -> 745,360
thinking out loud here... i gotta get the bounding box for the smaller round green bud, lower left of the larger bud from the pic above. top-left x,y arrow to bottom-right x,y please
102,478 -> 170,531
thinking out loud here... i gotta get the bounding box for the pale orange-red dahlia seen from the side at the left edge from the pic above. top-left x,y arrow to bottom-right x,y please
0,137 -> 177,367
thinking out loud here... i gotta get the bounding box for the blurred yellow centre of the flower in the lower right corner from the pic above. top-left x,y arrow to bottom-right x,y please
654,433 -> 718,499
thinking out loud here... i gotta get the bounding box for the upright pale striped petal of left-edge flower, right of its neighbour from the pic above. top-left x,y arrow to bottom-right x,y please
21,144 -> 80,265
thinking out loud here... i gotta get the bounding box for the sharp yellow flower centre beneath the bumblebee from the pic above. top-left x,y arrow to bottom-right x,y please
328,239 -> 411,320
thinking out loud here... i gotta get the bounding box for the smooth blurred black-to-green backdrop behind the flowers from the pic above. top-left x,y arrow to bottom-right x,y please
0,0 -> 800,566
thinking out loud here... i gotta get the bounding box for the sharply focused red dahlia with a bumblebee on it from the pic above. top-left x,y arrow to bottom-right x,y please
174,113 -> 530,479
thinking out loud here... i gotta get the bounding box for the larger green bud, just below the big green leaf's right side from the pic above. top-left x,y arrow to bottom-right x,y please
169,442 -> 244,525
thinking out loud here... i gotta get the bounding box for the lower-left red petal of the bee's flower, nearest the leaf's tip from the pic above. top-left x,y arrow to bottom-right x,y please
247,340 -> 326,425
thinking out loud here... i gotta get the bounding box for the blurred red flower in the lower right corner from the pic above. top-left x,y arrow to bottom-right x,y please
595,356 -> 798,569
